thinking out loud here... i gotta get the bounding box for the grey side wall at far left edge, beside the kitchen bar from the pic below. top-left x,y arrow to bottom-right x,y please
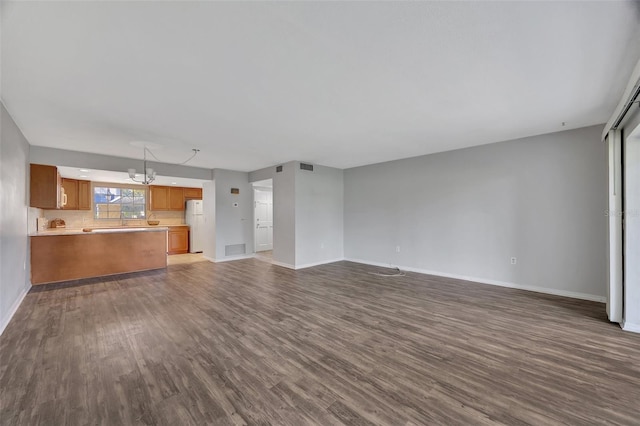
0,105 -> 31,333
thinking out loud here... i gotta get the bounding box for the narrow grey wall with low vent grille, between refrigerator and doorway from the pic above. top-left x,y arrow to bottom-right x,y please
210,169 -> 253,261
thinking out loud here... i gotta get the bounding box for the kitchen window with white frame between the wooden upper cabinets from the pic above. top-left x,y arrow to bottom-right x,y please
93,185 -> 147,219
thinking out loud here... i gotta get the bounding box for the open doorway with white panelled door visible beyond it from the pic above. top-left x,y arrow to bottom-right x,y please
253,179 -> 273,256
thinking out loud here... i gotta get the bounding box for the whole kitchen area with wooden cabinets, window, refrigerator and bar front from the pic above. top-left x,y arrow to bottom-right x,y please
29,164 -> 204,285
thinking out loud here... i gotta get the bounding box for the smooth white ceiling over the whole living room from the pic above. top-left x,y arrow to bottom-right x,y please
2,1 -> 640,171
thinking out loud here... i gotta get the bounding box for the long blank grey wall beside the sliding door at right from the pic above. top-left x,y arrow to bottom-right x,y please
344,126 -> 607,300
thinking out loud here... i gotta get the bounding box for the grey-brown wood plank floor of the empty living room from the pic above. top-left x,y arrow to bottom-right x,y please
0,259 -> 640,425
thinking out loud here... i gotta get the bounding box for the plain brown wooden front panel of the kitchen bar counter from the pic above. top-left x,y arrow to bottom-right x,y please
31,231 -> 167,284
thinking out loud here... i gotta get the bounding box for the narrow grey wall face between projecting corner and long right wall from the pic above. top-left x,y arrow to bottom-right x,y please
295,165 -> 344,268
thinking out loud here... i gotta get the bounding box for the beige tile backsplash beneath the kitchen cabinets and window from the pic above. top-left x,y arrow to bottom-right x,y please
42,210 -> 184,229
